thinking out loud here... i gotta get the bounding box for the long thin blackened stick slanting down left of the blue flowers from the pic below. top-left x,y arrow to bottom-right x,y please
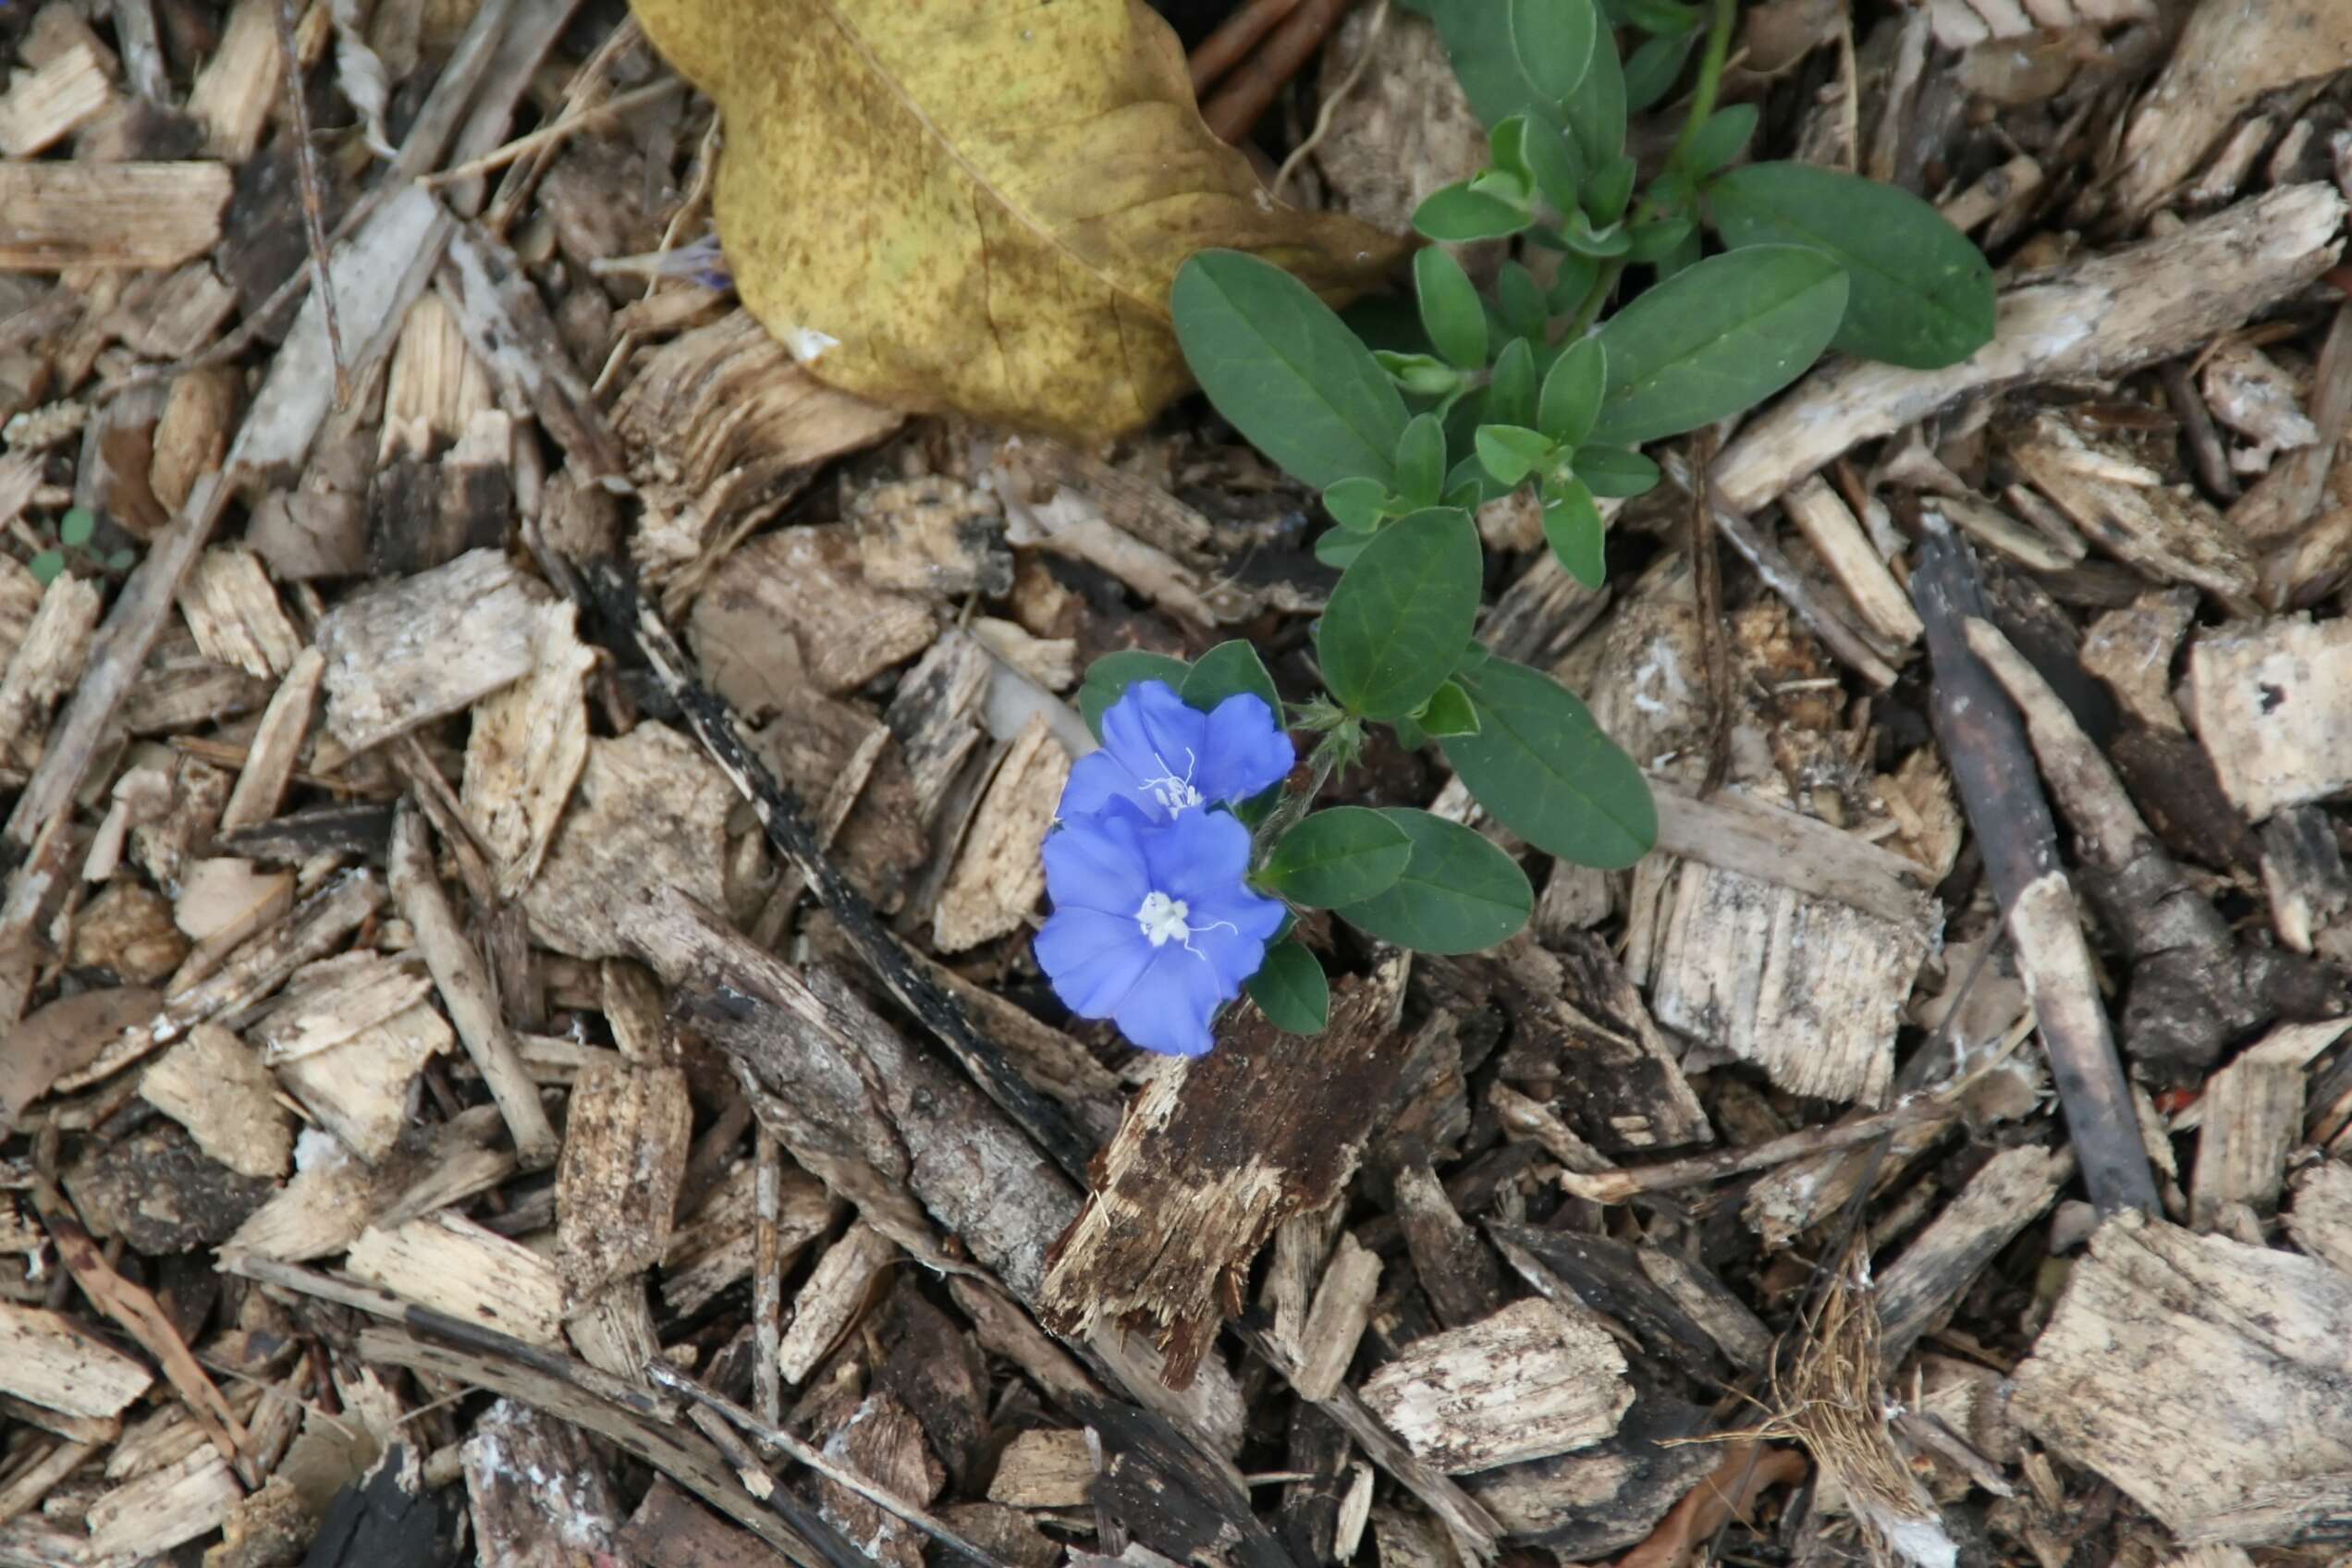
579,559 -> 1094,1187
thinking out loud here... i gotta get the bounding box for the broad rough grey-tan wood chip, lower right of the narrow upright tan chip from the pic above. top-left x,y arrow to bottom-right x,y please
522,724 -> 736,959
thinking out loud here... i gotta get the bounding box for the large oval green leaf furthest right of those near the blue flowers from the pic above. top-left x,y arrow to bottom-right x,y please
1444,658 -> 1659,870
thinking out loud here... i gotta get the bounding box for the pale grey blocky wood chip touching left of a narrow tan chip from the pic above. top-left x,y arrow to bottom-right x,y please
317,550 -> 545,753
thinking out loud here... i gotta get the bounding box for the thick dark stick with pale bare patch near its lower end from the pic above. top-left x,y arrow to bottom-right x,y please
1912,521 -> 2162,1216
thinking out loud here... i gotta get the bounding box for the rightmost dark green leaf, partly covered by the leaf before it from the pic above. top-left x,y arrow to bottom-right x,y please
1708,162 -> 1994,369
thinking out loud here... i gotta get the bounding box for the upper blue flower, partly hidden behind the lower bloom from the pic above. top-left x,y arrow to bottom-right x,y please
1059,681 -> 1298,820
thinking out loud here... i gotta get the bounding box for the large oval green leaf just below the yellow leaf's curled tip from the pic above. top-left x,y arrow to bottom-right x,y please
1169,251 -> 1404,489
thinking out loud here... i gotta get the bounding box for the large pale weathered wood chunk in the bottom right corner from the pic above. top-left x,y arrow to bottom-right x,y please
2011,1216 -> 2352,1545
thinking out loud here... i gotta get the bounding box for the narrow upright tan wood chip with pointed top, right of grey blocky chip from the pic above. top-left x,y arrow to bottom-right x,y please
459,602 -> 595,900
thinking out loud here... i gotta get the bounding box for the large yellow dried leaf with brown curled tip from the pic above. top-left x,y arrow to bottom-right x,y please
635,0 -> 1402,437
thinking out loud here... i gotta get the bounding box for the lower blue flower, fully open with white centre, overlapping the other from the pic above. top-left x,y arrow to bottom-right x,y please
1037,799 -> 1284,1056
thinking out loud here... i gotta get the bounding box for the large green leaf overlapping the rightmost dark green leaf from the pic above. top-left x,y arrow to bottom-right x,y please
1592,244 -> 1846,447
